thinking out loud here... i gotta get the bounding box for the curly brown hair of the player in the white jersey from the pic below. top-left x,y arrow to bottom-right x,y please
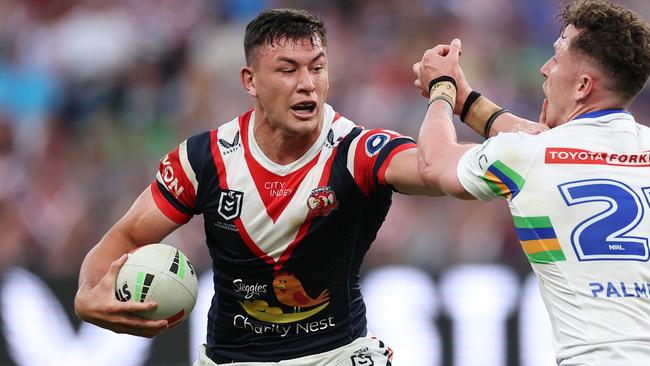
560,0 -> 650,101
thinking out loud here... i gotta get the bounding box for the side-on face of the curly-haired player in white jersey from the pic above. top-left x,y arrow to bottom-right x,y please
540,25 -> 580,127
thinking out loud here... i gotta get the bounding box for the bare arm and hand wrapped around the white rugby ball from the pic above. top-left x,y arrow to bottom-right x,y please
75,188 -> 180,337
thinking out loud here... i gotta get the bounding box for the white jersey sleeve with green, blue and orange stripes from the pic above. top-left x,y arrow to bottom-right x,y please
456,133 -> 534,201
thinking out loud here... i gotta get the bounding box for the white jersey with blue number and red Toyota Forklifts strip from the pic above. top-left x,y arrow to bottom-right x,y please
458,110 -> 650,366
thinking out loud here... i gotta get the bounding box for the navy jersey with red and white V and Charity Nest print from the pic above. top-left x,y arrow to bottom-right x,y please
151,106 -> 415,363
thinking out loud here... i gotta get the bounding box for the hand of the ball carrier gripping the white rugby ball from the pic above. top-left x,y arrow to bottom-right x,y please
75,254 -> 169,338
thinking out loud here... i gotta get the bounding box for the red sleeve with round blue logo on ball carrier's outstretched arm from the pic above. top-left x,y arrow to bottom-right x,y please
348,129 -> 417,195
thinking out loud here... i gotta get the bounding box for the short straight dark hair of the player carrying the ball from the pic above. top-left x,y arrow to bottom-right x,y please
244,9 -> 327,65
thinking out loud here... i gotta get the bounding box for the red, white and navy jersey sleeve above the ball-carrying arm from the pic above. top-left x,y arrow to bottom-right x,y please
151,133 -> 209,224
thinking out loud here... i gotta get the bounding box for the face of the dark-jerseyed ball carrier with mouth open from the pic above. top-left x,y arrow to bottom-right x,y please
242,38 -> 329,136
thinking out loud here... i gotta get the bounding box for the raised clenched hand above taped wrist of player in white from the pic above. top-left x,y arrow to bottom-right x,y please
413,39 -> 460,98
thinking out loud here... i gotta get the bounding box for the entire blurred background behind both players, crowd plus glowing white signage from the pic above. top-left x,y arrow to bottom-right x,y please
0,0 -> 650,366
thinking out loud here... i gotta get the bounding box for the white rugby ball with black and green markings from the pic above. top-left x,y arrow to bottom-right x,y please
115,244 -> 198,325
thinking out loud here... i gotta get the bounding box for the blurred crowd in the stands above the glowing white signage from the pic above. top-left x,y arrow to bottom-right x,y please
0,0 -> 650,277
